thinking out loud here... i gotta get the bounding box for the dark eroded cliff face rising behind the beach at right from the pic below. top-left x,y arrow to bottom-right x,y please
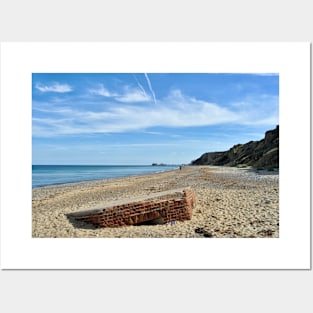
191,125 -> 279,169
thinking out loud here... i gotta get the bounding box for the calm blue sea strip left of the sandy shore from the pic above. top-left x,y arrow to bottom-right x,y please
32,165 -> 179,188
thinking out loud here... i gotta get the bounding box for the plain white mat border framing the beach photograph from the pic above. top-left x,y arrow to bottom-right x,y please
1,43 -> 310,269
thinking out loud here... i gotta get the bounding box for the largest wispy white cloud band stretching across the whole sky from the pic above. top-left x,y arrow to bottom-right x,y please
33,90 -> 277,136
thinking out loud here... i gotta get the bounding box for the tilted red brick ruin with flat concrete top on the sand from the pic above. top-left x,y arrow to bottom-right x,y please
67,188 -> 196,227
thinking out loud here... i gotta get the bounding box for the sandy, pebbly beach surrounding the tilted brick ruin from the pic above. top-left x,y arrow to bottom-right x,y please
32,166 -> 279,238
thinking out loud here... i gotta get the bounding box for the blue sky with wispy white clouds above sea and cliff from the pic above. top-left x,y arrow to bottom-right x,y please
32,73 -> 279,164
